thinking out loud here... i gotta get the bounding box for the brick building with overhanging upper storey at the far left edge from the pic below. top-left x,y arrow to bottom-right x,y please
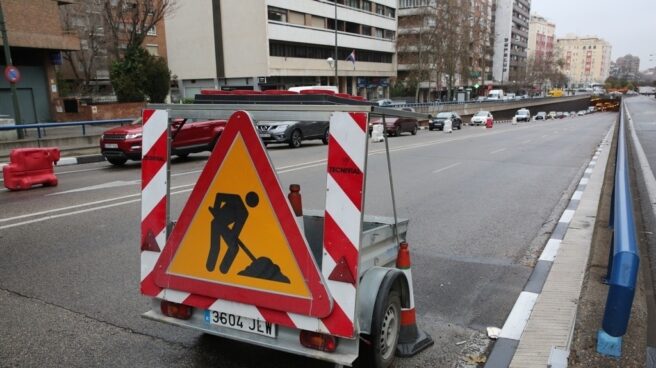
0,0 -> 80,123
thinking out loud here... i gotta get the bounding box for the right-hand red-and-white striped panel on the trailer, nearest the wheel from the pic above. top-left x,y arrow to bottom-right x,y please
321,112 -> 368,337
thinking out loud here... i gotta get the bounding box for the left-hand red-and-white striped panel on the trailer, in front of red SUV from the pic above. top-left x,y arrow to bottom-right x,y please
141,109 -> 169,296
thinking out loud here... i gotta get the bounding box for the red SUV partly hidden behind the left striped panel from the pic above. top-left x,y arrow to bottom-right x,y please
100,119 -> 226,165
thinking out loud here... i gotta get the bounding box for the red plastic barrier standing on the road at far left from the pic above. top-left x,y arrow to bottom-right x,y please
2,147 -> 59,190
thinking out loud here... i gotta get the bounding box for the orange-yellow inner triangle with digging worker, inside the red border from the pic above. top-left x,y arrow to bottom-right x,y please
166,134 -> 311,298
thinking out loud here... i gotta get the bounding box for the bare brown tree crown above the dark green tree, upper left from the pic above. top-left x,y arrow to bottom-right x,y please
101,0 -> 175,59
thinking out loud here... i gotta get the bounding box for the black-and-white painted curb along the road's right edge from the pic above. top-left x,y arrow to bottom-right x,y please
485,125 -> 615,368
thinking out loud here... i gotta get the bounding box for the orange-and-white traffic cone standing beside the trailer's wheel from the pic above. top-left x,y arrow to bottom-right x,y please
396,242 -> 434,357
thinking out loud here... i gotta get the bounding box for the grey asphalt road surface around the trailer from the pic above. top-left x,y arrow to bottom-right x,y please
0,113 -> 616,367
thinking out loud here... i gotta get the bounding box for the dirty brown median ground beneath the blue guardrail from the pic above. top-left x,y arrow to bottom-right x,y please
569,129 -> 651,368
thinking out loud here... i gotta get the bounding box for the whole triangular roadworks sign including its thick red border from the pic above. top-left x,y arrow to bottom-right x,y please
155,111 -> 332,317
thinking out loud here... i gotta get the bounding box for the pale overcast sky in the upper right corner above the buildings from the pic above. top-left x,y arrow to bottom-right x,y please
531,0 -> 656,70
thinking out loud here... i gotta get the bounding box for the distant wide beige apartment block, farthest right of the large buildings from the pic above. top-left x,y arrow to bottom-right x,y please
556,35 -> 612,88
